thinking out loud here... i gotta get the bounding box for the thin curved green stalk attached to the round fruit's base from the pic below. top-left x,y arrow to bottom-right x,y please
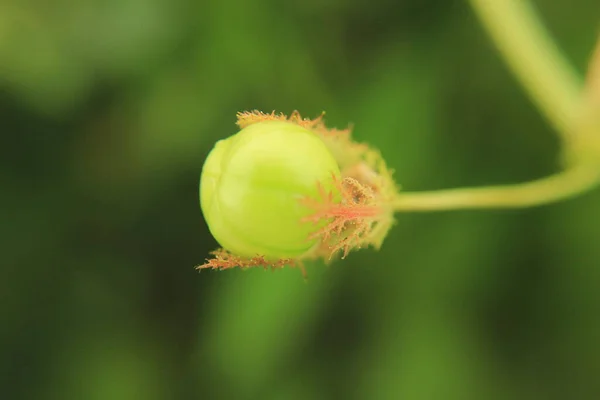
392,166 -> 600,212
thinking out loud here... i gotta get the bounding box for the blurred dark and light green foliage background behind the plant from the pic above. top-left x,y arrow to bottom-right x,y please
0,0 -> 600,400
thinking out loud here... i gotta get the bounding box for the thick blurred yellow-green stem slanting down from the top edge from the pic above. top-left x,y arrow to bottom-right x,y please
470,0 -> 581,138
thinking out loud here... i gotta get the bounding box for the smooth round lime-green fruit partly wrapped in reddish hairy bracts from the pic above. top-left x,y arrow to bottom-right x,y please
200,121 -> 340,260
